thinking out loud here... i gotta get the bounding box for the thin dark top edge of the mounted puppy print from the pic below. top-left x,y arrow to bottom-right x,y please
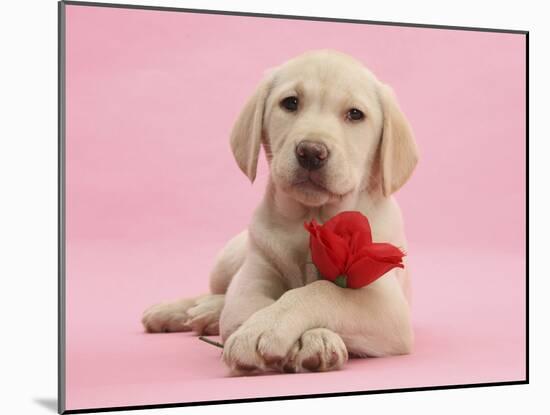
64,0 -> 528,35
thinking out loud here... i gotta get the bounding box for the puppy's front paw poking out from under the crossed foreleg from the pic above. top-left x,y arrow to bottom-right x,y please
283,328 -> 348,373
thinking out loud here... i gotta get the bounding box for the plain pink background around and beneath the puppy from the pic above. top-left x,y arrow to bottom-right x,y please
62,6 -> 526,409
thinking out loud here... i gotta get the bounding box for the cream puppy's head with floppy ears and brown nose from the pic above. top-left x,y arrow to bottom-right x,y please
231,51 -> 417,206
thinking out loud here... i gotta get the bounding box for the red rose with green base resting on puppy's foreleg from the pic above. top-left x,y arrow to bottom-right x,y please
304,212 -> 405,288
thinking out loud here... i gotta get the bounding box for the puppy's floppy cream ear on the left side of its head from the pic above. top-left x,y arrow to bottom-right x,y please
231,74 -> 273,182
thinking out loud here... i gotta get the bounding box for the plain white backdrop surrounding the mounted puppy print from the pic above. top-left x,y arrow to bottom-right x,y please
0,0 -> 550,415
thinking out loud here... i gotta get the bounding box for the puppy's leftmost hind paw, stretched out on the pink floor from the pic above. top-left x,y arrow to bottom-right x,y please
141,298 -> 195,333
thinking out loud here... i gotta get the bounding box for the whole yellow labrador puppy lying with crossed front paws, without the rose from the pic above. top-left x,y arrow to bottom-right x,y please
143,51 -> 417,374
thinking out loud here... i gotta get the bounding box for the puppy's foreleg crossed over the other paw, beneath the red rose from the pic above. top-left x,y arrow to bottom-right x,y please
223,271 -> 413,373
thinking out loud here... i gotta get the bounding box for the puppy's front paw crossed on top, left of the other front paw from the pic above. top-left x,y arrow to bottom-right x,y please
223,310 -> 296,375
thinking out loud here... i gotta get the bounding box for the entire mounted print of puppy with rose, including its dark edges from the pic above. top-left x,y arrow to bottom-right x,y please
59,1 -> 528,413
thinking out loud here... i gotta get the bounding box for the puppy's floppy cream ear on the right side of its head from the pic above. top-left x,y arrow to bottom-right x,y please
379,84 -> 418,196
